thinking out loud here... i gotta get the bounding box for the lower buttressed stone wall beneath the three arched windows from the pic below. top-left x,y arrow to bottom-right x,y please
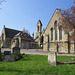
43,41 -> 75,53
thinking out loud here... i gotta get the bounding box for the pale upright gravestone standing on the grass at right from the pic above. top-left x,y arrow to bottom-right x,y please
48,52 -> 57,66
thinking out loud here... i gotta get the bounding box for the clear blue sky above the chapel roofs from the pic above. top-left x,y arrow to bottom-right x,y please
0,0 -> 73,35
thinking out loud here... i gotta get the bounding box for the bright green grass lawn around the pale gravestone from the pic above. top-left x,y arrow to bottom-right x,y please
0,54 -> 75,75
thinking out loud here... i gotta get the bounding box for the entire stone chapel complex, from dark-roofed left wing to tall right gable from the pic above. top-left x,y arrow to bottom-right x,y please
0,9 -> 75,53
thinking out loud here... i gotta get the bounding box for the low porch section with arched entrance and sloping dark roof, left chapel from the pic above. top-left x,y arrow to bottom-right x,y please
11,32 -> 36,49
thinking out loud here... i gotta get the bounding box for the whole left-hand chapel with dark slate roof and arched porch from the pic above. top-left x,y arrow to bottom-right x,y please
1,25 -> 35,48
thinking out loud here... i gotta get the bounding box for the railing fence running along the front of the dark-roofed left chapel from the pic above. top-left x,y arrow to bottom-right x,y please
1,42 -> 41,49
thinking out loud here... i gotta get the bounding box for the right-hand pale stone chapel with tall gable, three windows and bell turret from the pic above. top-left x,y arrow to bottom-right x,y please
35,9 -> 75,53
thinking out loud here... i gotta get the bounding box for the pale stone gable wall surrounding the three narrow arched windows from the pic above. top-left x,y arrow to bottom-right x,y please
43,10 -> 73,53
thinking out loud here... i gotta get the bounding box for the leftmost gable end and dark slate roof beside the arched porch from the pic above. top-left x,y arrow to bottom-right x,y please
1,25 -> 19,48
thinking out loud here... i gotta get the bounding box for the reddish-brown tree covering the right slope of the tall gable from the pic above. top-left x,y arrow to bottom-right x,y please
58,0 -> 75,41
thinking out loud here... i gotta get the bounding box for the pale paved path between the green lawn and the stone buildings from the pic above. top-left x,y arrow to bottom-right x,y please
1,48 -> 75,56
